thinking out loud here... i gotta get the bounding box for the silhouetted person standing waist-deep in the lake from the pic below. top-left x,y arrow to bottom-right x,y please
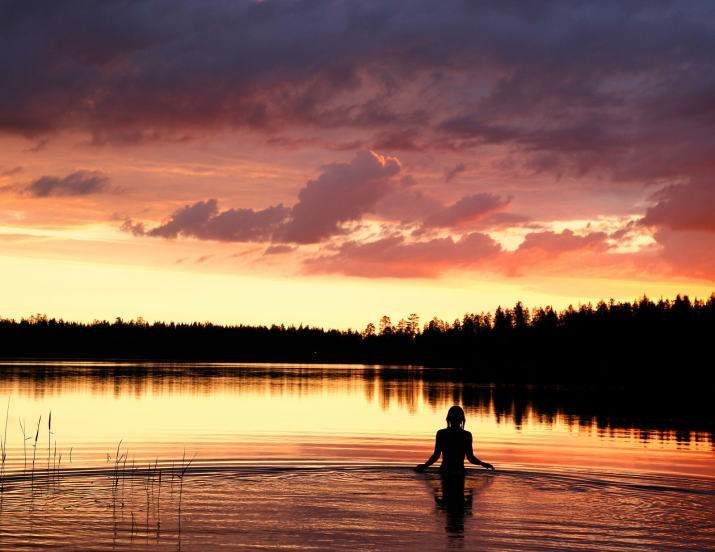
415,406 -> 494,475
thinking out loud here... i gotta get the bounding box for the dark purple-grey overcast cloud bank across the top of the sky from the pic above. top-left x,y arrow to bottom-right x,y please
0,0 -> 715,180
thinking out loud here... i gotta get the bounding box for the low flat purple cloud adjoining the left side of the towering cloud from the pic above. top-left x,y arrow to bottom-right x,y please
144,199 -> 289,242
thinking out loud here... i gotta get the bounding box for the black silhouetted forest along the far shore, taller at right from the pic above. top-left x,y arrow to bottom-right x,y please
0,294 -> 715,387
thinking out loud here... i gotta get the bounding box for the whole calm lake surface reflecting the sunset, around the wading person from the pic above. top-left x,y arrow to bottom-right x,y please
0,362 -> 715,550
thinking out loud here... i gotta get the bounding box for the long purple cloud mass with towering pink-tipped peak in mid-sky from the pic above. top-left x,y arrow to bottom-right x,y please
129,150 -> 523,249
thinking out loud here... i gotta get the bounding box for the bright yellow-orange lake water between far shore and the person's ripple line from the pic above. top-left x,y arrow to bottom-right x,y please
0,363 -> 715,477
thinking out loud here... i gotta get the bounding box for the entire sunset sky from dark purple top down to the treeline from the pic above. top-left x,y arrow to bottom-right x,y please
0,0 -> 715,328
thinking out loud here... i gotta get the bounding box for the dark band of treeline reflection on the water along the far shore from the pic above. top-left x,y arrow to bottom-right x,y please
0,362 -> 713,442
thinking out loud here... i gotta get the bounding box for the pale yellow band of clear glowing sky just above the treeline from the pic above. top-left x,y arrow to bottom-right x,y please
0,252 -> 712,329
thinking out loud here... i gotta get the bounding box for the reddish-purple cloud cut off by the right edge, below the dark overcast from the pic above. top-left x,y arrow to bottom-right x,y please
640,179 -> 715,232
